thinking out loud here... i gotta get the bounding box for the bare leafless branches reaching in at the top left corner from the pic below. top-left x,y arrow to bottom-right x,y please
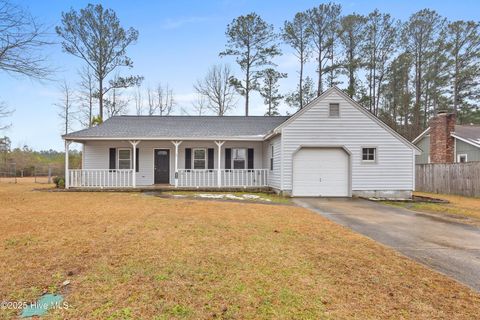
0,0 -> 51,79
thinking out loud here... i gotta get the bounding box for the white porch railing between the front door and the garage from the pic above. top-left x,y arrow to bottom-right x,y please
178,169 -> 268,188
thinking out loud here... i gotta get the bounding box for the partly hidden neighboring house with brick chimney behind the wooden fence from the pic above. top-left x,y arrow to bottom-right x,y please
413,112 -> 480,164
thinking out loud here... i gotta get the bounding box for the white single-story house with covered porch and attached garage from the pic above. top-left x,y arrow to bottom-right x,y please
63,88 -> 420,198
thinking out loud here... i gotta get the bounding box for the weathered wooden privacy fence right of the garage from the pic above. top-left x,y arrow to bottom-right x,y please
415,162 -> 480,197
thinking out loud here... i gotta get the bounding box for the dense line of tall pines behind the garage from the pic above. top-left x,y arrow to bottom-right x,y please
216,3 -> 480,139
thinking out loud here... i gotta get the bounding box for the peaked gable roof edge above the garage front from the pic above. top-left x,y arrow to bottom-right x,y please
273,86 -> 422,153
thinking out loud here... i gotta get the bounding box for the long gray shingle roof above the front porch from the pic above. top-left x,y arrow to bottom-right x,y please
63,116 -> 288,140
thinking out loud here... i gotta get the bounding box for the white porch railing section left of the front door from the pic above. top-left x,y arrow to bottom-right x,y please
68,169 -> 133,188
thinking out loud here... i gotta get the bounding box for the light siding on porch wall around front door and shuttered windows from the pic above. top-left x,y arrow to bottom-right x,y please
83,141 -> 262,186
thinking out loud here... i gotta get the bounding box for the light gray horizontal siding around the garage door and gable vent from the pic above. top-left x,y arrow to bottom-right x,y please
282,91 -> 414,191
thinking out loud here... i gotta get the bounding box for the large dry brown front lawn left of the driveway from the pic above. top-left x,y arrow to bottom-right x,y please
0,179 -> 480,319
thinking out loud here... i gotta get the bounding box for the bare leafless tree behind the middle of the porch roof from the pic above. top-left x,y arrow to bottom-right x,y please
193,65 -> 235,116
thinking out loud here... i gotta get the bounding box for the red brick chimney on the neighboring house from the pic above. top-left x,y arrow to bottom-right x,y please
430,111 -> 457,163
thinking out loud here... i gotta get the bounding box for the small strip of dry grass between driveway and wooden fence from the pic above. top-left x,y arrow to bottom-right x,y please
387,192 -> 480,225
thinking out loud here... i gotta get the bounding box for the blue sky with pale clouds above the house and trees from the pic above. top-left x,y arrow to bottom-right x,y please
0,0 -> 480,150
